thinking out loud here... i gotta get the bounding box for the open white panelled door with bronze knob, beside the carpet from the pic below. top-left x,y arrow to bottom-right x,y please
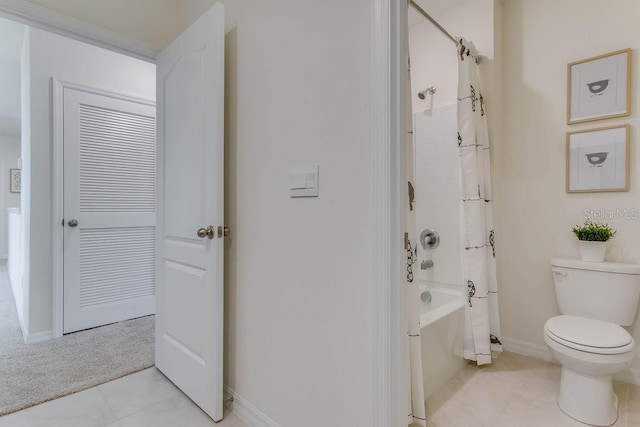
156,4 -> 225,421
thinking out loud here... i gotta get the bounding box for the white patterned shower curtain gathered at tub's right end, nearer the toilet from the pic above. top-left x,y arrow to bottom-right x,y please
458,39 -> 502,365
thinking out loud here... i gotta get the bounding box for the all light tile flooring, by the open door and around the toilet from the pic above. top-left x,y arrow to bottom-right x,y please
5,352 -> 640,427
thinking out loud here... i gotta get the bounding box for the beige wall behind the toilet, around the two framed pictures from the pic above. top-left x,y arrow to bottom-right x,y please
494,0 -> 640,369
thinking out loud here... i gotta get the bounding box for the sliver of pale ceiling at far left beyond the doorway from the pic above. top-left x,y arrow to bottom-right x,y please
0,18 -> 26,135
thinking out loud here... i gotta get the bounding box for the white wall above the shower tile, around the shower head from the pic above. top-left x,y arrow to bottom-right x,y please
409,0 -> 495,112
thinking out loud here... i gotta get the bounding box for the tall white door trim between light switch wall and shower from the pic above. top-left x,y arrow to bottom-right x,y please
369,0 -> 410,427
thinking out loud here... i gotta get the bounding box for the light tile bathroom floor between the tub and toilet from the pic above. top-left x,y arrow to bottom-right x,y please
418,352 -> 640,427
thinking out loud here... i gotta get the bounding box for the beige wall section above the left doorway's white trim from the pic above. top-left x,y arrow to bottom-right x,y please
28,0 -> 180,49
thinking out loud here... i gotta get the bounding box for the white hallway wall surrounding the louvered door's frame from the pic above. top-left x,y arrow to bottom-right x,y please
22,29 -> 155,334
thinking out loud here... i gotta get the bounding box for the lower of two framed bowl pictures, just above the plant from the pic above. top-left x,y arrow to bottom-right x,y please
567,125 -> 629,193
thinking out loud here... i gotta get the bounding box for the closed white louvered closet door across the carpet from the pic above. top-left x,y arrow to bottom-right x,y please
64,88 -> 156,333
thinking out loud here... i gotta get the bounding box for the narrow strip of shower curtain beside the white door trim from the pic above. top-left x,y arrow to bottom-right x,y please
404,51 -> 427,426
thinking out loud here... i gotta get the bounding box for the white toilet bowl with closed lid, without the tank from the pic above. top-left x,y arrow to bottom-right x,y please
544,315 -> 635,426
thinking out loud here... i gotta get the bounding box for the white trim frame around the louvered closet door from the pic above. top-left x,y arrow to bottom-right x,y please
51,77 -> 157,338
